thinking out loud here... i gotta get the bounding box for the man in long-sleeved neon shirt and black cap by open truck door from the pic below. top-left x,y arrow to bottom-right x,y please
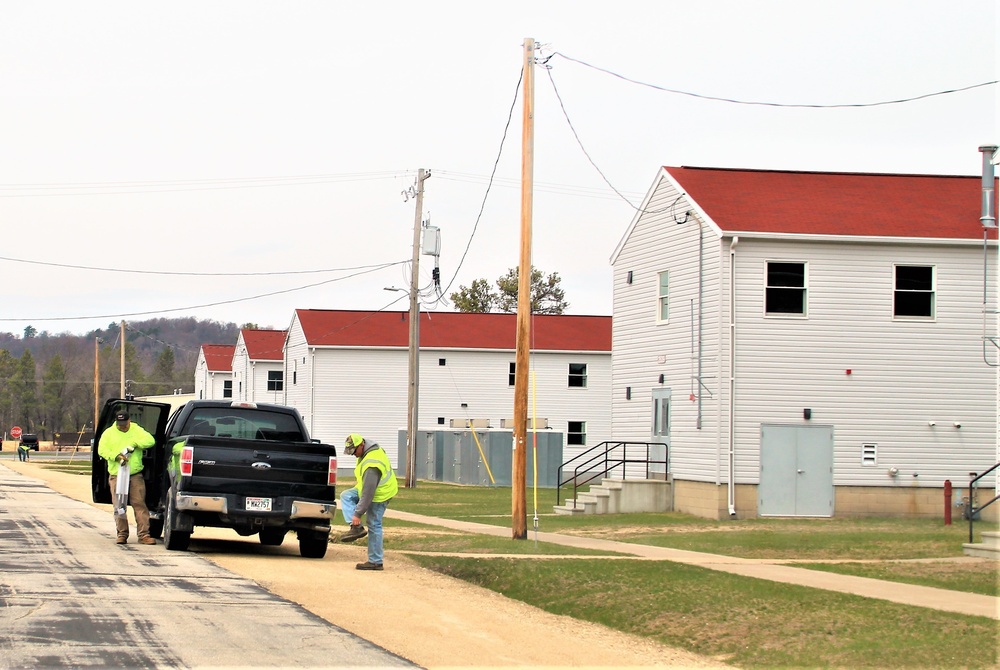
97,410 -> 156,544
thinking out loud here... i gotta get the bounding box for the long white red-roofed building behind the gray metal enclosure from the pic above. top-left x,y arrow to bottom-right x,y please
284,309 -> 611,466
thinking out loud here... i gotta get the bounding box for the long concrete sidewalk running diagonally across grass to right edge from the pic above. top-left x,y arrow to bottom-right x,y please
386,508 -> 1000,620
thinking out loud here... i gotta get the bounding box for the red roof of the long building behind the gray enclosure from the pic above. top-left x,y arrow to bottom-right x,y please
295,309 -> 611,351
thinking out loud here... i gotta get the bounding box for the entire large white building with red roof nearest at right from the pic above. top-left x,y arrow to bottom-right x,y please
611,167 -> 1000,518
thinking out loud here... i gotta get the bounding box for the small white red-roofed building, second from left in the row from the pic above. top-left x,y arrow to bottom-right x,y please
233,328 -> 285,403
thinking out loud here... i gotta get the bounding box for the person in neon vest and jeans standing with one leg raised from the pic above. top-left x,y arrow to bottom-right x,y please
340,433 -> 399,570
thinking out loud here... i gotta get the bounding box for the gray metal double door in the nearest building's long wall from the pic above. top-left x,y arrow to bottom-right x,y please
757,424 -> 834,516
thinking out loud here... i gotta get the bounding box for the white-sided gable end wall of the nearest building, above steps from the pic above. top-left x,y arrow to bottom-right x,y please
612,180 -> 728,482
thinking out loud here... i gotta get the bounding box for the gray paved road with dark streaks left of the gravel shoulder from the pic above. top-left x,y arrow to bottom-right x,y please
0,468 -> 413,668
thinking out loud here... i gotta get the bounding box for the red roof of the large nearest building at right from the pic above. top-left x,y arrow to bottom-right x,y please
664,167 -> 995,240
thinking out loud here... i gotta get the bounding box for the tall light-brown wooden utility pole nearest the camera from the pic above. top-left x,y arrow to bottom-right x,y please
511,37 -> 535,540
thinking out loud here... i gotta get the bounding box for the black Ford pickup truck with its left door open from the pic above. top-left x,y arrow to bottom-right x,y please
92,399 -> 337,558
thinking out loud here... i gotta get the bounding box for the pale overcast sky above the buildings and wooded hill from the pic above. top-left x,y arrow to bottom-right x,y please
0,0 -> 1000,333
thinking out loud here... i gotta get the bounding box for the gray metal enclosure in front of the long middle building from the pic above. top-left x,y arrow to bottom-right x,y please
398,428 -> 563,488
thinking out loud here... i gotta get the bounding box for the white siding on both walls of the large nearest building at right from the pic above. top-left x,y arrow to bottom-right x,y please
612,171 -> 997,486
